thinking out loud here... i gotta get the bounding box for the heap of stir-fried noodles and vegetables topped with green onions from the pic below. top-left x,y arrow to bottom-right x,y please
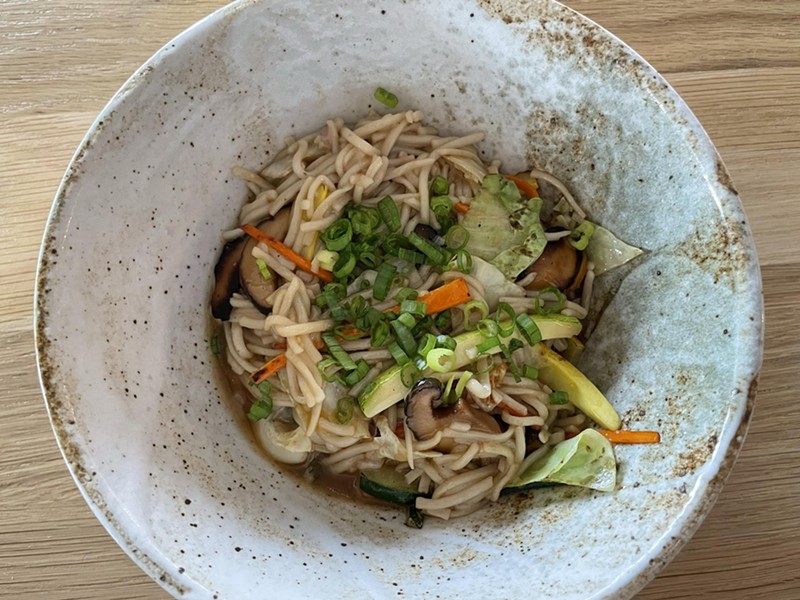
212,111 -> 644,524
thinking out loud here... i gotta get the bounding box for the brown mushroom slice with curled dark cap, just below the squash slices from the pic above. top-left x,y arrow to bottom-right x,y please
406,378 -> 501,448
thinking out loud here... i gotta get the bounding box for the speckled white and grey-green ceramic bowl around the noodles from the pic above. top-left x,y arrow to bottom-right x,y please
36,0 -> 762,600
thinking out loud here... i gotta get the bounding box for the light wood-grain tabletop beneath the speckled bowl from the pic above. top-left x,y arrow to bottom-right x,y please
0,0 -> 800,600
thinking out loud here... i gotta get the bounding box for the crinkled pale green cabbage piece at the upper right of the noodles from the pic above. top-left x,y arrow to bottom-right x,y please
463,175 -> 547,281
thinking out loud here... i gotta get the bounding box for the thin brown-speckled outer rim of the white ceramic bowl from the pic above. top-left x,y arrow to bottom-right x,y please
33,0 -> 764,598
